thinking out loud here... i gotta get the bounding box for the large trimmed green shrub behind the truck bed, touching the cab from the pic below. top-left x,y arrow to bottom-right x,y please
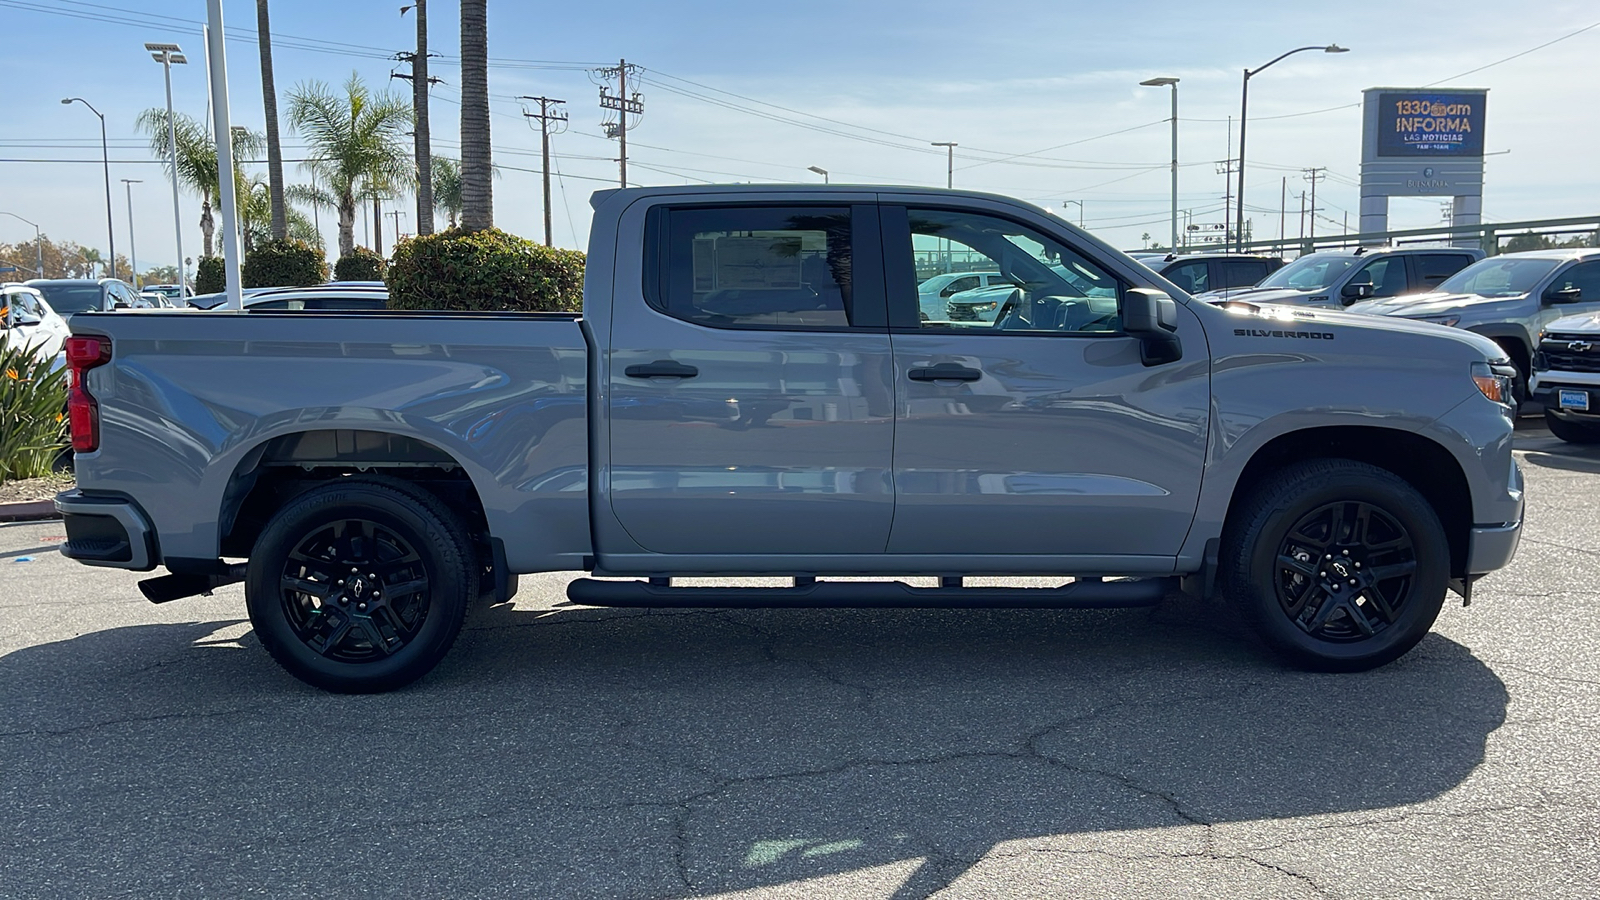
386,229 -> 584,312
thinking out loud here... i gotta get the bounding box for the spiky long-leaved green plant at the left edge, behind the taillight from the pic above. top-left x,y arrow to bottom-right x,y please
0,333 -> 67,484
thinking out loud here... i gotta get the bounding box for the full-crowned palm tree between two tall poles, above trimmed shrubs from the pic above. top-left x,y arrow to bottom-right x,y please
290,72 -> 413,256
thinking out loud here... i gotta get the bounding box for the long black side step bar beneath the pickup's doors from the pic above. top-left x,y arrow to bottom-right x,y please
566,578 -> 1178,609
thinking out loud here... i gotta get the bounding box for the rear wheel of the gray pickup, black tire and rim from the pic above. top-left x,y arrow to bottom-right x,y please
245,477 -> 478,693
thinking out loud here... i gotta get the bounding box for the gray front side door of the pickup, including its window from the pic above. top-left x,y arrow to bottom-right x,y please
880,205 -> 1210,557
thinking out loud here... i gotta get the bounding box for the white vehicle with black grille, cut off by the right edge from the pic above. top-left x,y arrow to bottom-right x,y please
1531,312 -> 1600,444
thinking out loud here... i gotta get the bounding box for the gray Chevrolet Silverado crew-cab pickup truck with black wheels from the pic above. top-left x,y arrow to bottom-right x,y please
56,186 -> 1523,692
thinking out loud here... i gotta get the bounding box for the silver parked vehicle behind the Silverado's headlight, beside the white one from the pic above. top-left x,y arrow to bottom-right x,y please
1350,248 -> 1600,399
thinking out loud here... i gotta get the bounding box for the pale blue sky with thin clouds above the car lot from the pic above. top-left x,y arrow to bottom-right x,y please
0,0 -> 1600,266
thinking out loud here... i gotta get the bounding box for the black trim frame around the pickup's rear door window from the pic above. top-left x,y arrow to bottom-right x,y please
640,200 -> 888,335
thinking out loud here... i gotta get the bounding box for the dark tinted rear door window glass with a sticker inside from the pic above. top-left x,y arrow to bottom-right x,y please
650,207 -> 854,328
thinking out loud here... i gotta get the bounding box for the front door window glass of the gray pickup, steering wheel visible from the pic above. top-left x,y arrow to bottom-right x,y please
908,210 -> 1122,333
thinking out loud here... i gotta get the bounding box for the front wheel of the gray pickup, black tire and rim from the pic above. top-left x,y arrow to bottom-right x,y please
1221,460 -> 1450,671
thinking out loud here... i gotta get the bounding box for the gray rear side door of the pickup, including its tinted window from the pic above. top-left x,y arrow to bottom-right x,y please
602,199 -> 896,556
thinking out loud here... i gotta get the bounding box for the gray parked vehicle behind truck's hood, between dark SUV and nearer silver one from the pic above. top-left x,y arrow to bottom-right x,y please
1200,247 -> 1483,309
